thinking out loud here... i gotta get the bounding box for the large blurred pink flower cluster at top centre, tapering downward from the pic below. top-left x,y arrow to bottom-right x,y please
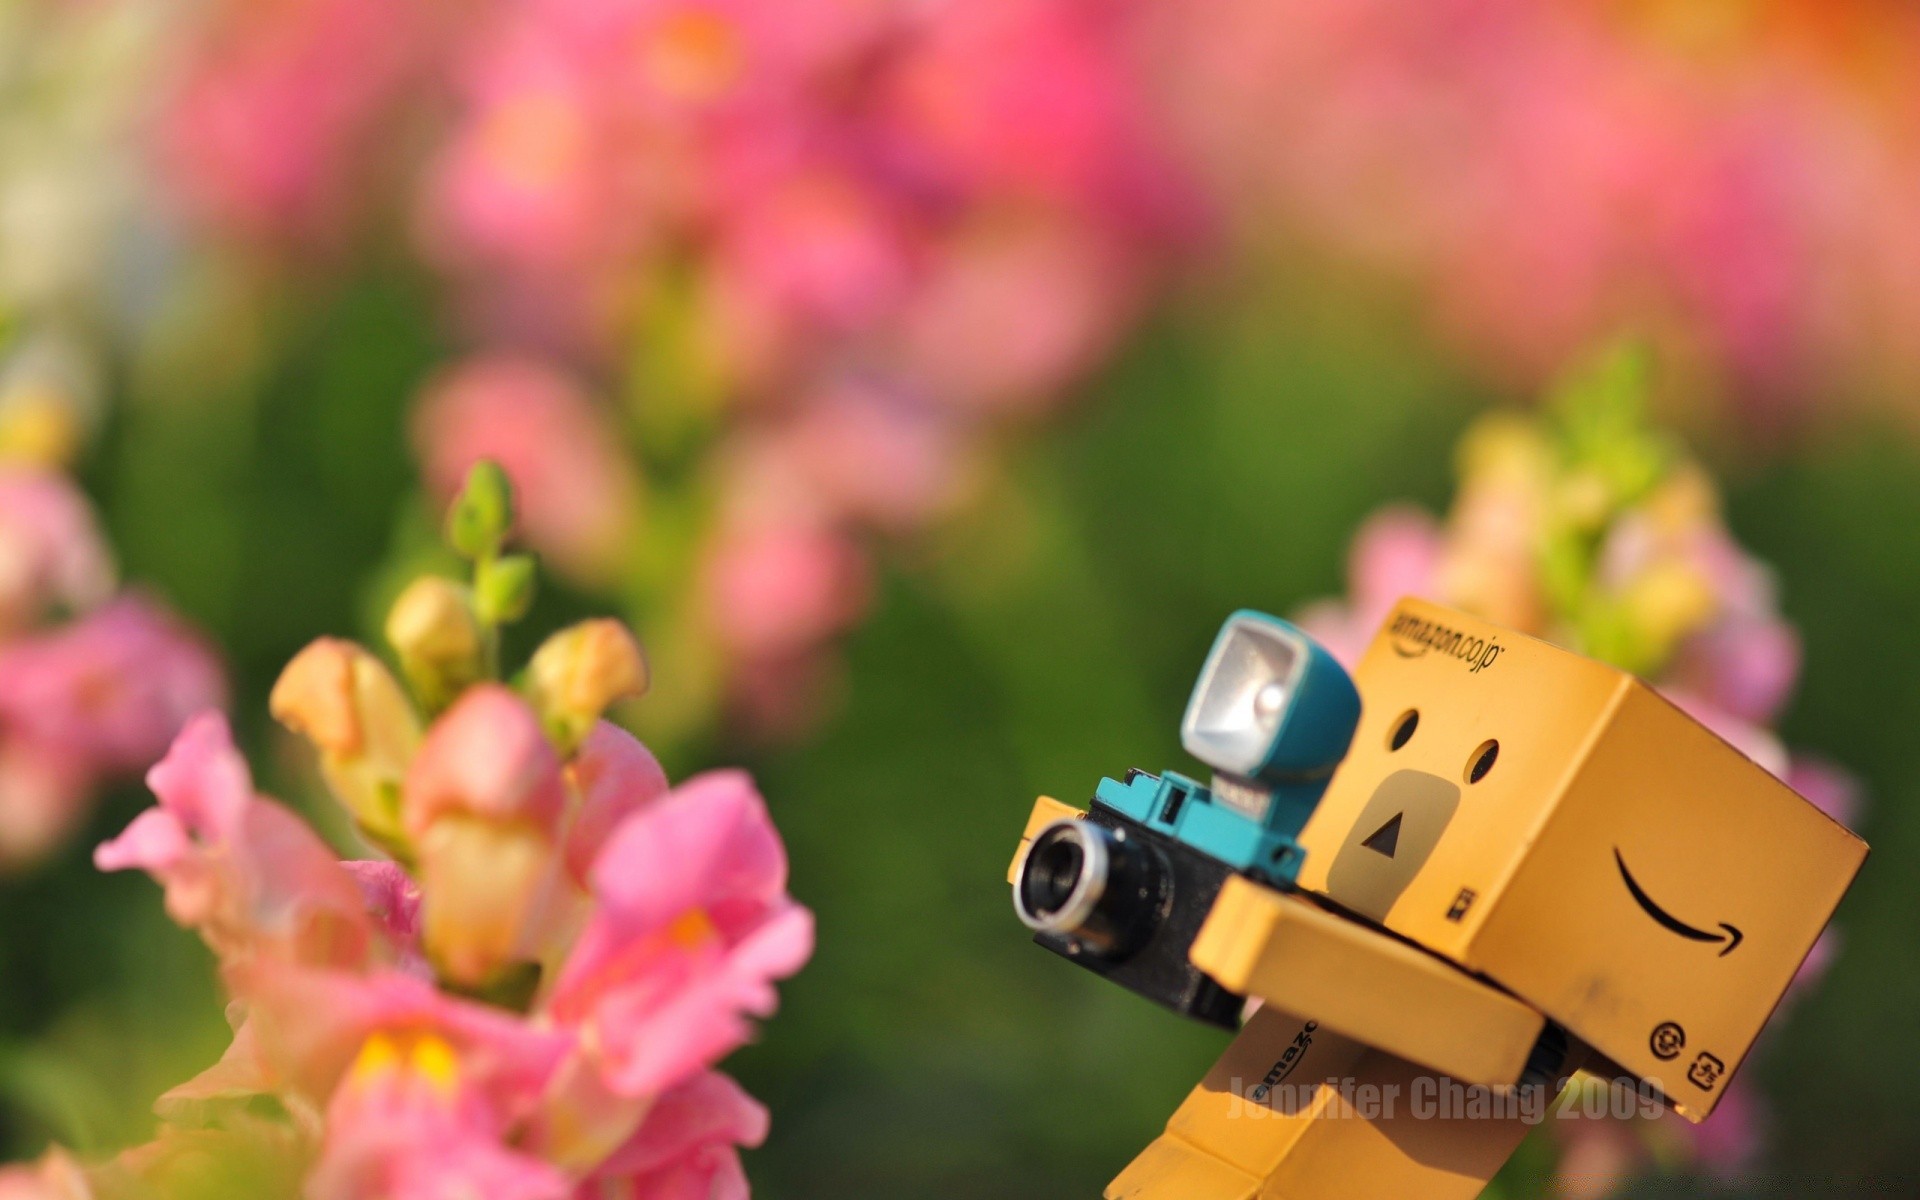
149,0 -> 1198,741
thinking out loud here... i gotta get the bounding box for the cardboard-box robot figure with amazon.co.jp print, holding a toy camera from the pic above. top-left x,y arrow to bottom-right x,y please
1012,599 -> 1866,1200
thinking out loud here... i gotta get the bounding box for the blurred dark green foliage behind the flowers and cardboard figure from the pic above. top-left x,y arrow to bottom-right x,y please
0,266 -> 1920,1198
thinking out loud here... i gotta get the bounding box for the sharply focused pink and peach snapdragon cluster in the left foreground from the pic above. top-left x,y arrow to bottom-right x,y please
10,467 -> 812,1200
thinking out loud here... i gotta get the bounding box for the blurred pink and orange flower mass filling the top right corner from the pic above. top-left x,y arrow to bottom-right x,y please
1156,0 -> 1920,411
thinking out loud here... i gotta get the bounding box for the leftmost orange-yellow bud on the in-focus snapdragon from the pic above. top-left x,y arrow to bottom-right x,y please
267,637 -> 420,851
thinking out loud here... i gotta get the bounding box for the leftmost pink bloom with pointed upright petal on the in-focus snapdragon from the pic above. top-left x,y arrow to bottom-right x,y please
94,712 -> 372,968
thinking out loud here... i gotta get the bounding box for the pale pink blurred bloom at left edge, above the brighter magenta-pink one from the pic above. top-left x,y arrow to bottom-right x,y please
0,467 -> 113,636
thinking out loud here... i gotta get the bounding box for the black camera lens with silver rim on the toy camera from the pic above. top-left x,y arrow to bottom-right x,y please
1014,820 -> 1164,958
